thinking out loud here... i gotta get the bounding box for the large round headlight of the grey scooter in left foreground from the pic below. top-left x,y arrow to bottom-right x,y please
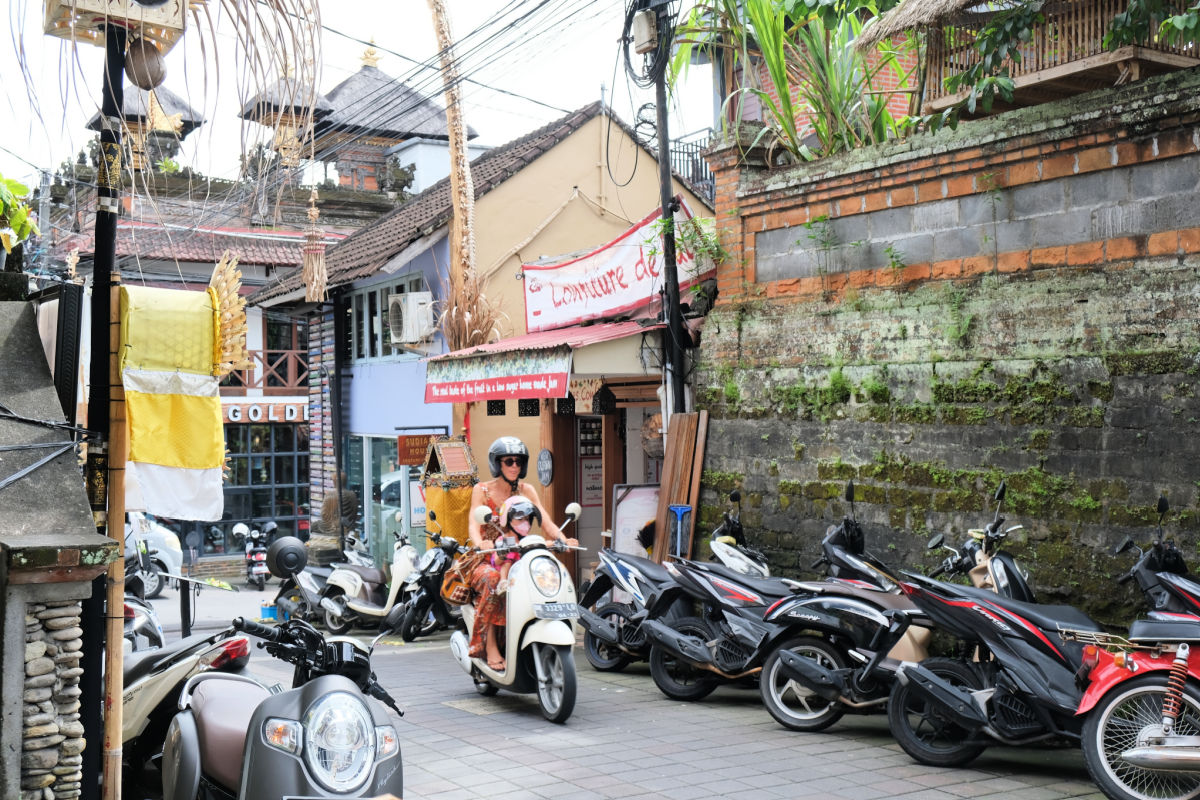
304,692 -> 376,793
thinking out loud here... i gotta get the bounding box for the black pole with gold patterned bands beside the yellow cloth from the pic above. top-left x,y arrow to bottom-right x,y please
79,25 -> 126,800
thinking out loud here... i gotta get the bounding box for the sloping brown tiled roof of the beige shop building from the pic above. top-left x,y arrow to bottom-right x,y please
251,102 -> 602,305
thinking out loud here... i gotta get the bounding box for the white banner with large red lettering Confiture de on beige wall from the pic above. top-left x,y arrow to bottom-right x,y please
521,199 -> 712,332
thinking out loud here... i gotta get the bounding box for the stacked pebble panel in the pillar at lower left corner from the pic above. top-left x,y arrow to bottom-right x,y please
20,601 -> 84,800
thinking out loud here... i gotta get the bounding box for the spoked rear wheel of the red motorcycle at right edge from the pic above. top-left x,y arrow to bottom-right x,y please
1081,673 -> 1200,800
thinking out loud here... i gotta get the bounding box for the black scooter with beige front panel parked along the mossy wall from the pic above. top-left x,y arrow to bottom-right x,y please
760,482 -> 1033,730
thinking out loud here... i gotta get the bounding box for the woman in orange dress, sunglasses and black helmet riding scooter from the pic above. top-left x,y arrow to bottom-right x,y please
468,437 -> 578,672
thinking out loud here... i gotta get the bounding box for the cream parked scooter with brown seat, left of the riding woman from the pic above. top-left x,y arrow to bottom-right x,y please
320,530 -> 416,636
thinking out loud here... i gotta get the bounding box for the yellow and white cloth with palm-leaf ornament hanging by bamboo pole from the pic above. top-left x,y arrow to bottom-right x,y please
120,258 -> 246,521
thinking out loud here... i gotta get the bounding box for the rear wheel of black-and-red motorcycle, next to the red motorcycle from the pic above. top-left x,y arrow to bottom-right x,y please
888,658 -> 985,766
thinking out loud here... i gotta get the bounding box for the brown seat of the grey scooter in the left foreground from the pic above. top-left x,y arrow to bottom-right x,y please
192,680 -> 271,795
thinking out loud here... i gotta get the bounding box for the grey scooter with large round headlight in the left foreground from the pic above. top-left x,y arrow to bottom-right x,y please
163,537 -> 403,800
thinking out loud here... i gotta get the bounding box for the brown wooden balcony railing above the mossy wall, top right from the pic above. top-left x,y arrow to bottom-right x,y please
925,0 -> 1200,108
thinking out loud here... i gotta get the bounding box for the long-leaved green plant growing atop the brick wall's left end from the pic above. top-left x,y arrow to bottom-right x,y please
673,0 -> 907,160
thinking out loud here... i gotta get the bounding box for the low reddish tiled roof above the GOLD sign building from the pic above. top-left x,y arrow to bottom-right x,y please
54,222 -> 343,267
